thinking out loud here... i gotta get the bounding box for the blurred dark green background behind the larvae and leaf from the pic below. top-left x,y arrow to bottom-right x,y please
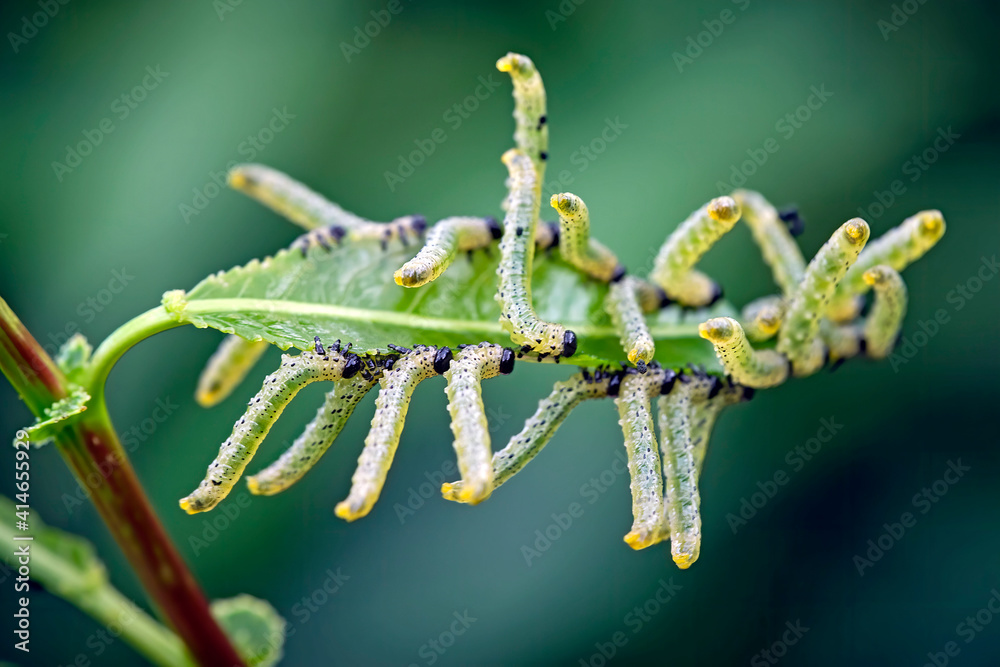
0,0 -> 1000,666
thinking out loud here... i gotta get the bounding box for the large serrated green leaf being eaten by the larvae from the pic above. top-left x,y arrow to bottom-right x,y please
163,242 -> 733,370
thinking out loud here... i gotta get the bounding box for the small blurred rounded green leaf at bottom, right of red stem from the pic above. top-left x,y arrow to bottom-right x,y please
212,594 -> 285,667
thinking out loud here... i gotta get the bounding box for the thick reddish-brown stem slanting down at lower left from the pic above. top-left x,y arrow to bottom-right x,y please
0,299 -> 245,667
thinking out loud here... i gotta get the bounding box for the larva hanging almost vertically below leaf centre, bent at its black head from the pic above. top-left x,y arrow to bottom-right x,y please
441,344 -> 514,505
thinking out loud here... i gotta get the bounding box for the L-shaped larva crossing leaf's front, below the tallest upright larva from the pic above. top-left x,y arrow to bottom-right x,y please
496,149 -> 576,357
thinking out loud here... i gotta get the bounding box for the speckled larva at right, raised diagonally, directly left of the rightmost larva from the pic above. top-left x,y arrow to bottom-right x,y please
772,218 -> 869,376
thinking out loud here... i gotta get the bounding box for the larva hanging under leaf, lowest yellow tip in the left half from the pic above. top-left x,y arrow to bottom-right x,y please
335,347 -> 451,521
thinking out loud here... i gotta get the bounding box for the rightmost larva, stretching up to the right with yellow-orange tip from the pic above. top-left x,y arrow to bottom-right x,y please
828,210 -> 947,321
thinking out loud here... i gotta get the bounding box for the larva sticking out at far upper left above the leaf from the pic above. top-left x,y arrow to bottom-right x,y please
229,164 -> 368,230
